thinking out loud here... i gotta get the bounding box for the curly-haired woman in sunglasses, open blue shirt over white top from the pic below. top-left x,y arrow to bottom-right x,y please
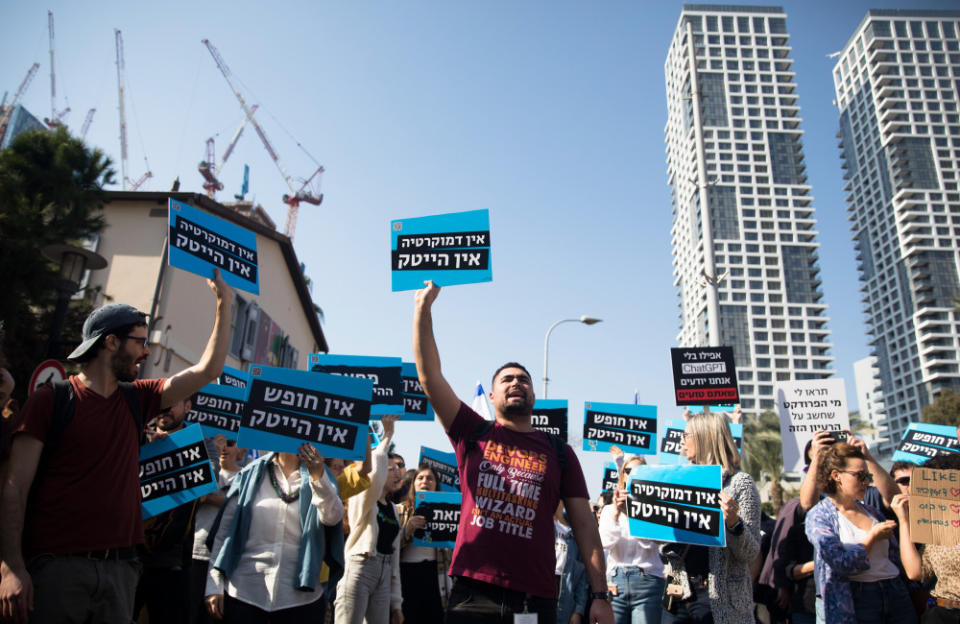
805,442 -> 917,624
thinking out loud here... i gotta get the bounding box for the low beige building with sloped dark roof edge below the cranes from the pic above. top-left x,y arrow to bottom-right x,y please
86,191 -> 328,378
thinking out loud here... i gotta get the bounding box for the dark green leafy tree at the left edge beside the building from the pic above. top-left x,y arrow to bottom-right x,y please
0,127 -> 114,398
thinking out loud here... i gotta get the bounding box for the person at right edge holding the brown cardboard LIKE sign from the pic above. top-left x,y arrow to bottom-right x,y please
891,453 -> 960,624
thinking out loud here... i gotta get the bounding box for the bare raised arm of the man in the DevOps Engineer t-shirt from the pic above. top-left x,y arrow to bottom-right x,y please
413,281 -> 460,430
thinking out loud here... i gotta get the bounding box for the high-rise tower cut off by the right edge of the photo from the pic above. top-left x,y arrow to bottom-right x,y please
833,10 -> 960,451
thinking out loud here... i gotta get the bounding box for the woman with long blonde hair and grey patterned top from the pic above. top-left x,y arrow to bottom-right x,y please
660,412 -> 760,624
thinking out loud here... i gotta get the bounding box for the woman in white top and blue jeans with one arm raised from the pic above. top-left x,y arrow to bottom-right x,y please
600,456 -> 663,624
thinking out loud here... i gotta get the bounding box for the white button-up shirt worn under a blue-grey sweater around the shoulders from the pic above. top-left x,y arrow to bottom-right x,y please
206,464 -> 343,611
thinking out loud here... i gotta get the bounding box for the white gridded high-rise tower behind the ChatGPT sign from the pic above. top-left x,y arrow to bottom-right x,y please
665,5 -> 833,413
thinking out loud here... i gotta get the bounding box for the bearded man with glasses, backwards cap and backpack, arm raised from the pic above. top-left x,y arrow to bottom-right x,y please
0,271 -> 233,622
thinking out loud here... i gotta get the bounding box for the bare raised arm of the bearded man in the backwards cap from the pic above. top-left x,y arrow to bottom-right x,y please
160,269 -> 233,407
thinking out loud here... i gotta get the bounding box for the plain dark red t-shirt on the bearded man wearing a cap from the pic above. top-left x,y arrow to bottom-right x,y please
16,377 -> 166,557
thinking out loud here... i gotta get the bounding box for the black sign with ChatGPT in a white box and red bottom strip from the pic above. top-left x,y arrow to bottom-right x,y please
670,347 -> 740,405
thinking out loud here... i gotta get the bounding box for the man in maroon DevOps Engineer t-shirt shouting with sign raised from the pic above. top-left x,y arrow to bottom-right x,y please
413,282 -> 613,624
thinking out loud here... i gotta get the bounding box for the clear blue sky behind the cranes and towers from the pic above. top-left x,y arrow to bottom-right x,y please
0,0 -> 956,494
